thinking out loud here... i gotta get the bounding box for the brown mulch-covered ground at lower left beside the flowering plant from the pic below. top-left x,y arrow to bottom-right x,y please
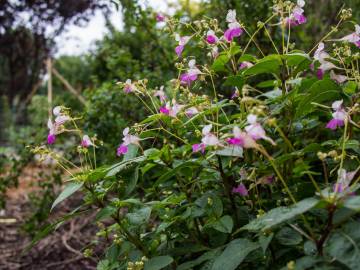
0,166 -> 101,270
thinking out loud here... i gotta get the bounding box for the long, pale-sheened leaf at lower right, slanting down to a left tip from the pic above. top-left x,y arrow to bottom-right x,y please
237,198 -> 319,232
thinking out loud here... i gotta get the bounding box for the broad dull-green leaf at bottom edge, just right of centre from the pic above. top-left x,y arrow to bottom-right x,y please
211,239 -> 259,270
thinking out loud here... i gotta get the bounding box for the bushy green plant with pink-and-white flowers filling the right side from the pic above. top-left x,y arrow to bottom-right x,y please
34,1 -> 360,270
